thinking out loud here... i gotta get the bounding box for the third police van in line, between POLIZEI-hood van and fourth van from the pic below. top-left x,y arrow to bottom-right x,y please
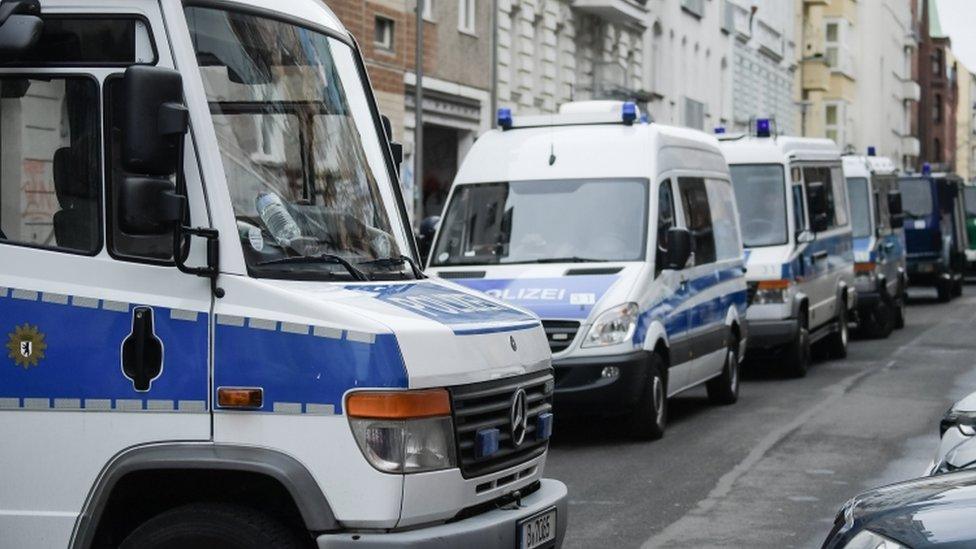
721,119 -> 856,376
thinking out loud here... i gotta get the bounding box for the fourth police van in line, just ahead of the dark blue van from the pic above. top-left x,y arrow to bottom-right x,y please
844,152 -> 908,337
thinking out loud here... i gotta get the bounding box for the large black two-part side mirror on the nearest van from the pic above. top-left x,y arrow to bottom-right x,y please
118,66 -> 189,236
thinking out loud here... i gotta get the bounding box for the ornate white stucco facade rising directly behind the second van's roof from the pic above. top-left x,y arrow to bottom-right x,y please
497,0 -> 648,114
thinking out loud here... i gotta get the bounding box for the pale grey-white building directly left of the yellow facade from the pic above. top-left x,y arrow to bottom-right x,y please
722,0 -> 799,135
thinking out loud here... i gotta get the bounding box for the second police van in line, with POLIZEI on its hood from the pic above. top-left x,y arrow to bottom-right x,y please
428,101 -> 746,438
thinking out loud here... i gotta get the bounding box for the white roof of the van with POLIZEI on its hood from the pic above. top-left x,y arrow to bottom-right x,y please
455,123 -> 728,184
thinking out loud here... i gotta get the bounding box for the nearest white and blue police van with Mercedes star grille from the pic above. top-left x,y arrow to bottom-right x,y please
0,0 -> 567,548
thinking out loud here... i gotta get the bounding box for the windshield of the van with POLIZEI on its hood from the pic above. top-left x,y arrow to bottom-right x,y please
431,179 -> 648,266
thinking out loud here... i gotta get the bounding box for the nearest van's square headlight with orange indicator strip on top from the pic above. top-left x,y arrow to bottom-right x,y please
346,389 -> 457,473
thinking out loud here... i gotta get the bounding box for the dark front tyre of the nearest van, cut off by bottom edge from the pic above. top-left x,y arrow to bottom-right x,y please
119,503 -> 304,549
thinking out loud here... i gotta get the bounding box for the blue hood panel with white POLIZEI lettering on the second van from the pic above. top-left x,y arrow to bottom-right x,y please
455,275 -> 619,320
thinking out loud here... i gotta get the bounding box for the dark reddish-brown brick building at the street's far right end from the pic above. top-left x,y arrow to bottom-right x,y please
918,0 -> 958,171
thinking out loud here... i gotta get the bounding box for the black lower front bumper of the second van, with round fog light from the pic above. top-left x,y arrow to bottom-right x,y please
552,350 -> 650,417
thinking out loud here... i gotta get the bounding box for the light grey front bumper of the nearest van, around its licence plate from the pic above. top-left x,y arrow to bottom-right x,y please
316,479 -> 569,549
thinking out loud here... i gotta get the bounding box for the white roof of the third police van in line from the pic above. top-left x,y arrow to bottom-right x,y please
721,136 -> 840,164
